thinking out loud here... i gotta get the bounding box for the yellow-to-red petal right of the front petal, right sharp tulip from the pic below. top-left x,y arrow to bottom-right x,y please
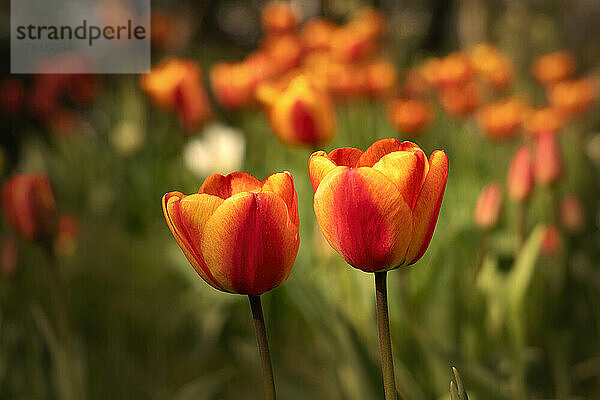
373,151 -> 427,210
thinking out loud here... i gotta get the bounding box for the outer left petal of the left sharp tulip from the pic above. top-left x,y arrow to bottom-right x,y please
162,192 -> 225,290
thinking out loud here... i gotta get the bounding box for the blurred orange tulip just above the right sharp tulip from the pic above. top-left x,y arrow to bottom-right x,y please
387,99 -> 433,136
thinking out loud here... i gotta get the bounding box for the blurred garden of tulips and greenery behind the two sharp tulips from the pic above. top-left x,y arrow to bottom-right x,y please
0,0 -> 600,400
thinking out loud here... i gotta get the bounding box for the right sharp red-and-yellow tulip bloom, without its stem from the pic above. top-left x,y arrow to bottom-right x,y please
309,138 -> 448,272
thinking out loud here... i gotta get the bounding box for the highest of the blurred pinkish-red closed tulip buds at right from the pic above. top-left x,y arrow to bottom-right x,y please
534,132 -> 562,185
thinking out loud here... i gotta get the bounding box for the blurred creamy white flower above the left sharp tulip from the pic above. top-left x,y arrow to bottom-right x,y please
183,123 -> 246,177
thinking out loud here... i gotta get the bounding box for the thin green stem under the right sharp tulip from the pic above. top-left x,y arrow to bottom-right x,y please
375,271 -> 397,400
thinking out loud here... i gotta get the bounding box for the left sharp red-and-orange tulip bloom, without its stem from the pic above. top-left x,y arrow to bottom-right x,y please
162,172 -> 300,295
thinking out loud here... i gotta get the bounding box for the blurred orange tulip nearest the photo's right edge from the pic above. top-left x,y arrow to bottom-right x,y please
548,79 -> 594,116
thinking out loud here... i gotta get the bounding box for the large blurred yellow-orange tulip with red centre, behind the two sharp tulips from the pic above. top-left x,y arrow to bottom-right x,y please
262,75 -> 336,146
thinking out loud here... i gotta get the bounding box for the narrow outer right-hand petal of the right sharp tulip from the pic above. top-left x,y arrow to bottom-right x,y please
406,151 -> 448,265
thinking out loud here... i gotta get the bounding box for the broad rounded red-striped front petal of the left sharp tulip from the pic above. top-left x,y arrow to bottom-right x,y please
201,192 -> 299,295
